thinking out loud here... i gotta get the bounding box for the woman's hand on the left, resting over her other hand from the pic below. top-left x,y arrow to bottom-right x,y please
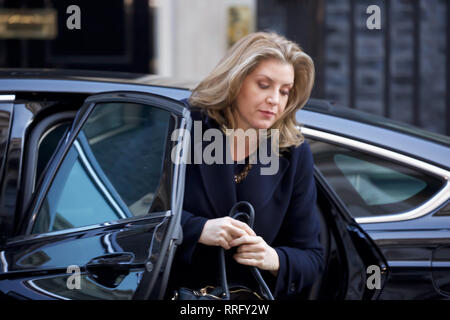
198,217 -> 256,250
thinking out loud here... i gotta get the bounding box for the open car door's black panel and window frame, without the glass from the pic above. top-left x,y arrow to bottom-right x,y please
0,92 -> 189,299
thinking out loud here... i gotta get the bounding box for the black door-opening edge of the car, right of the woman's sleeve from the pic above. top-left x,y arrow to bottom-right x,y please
307,167 -> 388,300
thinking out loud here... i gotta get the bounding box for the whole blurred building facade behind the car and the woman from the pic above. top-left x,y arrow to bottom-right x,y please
0,0 -> 450,135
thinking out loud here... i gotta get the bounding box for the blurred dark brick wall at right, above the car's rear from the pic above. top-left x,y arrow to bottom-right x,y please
316,0 -> 449,135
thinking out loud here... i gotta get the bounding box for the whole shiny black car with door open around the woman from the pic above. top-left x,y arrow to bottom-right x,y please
0,70 -> 450,300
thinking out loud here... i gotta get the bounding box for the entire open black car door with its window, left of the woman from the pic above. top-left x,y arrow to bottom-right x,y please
0,92 -> 191,299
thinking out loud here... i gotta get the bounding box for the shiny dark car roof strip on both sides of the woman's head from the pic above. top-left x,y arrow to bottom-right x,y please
0,69 -> 450,169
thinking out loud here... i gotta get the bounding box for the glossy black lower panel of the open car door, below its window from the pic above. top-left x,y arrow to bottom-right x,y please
0,213 -> 170,300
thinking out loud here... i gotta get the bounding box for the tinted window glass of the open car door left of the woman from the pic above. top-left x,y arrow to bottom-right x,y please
32,103 -> 172,233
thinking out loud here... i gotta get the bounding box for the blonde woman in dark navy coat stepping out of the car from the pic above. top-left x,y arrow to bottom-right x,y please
169,32 -> 324,299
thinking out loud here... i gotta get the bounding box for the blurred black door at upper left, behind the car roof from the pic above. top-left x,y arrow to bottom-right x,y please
0,0 -> 153,73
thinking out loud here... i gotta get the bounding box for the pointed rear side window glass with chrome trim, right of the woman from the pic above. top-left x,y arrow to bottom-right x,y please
308,139 -> 444,218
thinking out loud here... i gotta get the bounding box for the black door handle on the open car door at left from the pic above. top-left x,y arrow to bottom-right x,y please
86,252 -> 145,288
